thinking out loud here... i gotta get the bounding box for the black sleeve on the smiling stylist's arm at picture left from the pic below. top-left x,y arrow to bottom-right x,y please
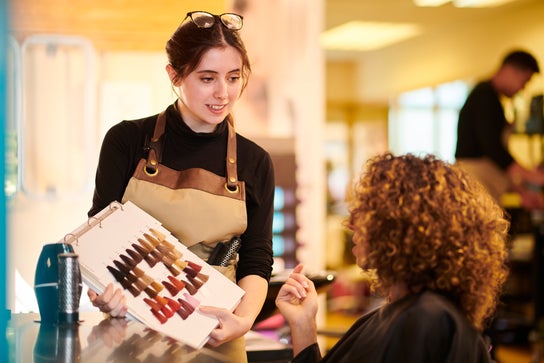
88,121 -> 147,217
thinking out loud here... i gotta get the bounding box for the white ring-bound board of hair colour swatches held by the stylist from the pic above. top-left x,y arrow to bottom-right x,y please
61,202 -> 244,349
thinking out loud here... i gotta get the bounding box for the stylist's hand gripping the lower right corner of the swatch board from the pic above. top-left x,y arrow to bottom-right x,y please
199,306 -> 253,347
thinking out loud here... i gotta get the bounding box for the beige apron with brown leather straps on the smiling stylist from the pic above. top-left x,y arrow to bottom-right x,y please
122,112 -> 247,362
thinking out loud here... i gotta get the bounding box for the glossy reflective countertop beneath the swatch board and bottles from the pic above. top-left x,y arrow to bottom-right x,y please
6,312 -> 292,363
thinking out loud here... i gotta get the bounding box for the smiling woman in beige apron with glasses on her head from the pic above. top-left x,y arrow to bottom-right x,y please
89,11 -> 274,362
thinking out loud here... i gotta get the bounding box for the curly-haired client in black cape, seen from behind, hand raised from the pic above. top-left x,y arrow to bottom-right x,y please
276,153 -> 509,363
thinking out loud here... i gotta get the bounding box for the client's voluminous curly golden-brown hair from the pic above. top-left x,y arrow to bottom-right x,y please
348,153 -> 510,330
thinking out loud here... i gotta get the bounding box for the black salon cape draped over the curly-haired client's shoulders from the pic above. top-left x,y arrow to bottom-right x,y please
293,291 -> 491,363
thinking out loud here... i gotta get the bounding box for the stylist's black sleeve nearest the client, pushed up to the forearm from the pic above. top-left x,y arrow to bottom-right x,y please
236,140 -> 275,281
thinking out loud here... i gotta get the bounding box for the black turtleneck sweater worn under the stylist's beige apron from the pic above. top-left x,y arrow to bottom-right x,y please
88,105 -> 274,280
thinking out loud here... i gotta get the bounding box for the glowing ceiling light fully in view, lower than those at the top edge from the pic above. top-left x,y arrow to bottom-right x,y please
319,21 -> 421,51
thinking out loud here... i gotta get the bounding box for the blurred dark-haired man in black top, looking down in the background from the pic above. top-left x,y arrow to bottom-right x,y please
455,50 -> 544,210
